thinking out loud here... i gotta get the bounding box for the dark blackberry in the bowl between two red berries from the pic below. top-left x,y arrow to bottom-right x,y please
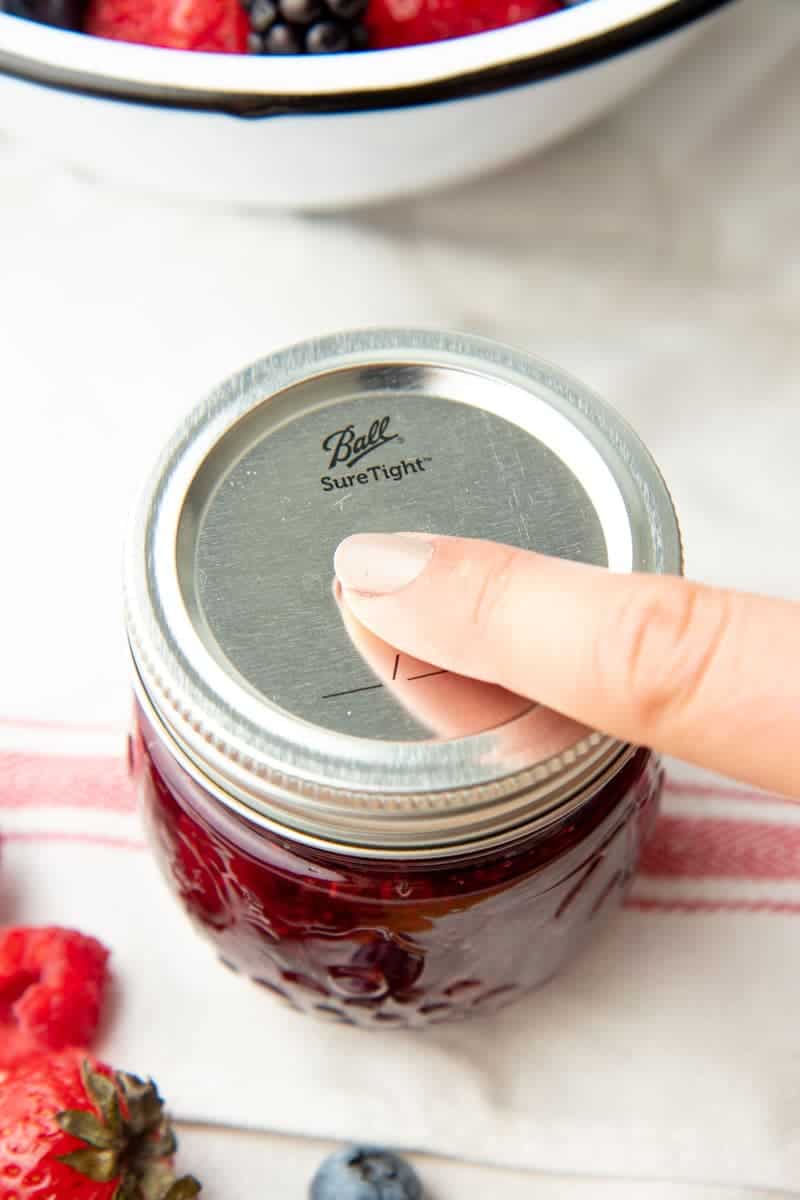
242,0 -> 367,54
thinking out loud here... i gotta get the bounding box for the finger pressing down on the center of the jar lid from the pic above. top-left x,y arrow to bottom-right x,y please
335,534 -> 800,798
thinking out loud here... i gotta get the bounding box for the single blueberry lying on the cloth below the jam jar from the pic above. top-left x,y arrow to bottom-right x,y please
311,1146 -> 422,1200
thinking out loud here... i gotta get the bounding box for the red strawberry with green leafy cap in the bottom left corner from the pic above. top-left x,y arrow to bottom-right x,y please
0,1050 -> 200,1200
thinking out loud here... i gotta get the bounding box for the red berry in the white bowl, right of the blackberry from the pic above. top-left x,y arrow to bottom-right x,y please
367,0 -> 563,49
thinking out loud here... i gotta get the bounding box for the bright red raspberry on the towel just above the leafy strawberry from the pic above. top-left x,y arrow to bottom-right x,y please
0,928 -> 108,1067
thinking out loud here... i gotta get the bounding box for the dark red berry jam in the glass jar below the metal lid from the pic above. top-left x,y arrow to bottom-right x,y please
134,710 -> 663,1027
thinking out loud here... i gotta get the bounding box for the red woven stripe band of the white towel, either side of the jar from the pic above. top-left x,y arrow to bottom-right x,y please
6,719 -> 800,914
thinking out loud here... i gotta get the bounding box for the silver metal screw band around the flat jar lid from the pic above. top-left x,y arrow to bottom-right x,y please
125,330 -> 682,847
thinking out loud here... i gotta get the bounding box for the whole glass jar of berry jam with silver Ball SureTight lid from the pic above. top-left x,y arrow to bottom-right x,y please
126,331 -> 681,1027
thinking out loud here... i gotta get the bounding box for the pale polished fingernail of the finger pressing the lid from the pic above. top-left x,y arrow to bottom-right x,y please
333,533 -> 433,595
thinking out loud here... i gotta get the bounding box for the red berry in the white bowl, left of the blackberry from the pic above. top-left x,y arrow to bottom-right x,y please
85,0 -> 249,54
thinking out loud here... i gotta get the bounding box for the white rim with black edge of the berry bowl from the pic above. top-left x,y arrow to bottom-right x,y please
0,0 -> 732,118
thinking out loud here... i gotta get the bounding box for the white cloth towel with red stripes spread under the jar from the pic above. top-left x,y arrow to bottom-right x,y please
0,0 -> 800,1200
